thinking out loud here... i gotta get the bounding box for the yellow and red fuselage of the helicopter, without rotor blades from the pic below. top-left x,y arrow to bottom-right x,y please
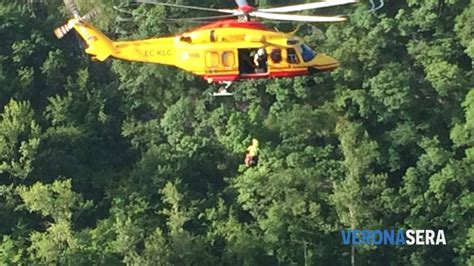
74,20 -> 339,82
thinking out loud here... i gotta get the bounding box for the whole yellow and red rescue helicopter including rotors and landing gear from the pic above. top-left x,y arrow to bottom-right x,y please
54,0 -> 356,95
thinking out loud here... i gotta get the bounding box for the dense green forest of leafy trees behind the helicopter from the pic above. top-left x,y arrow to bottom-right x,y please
0,0 -> 474,265
